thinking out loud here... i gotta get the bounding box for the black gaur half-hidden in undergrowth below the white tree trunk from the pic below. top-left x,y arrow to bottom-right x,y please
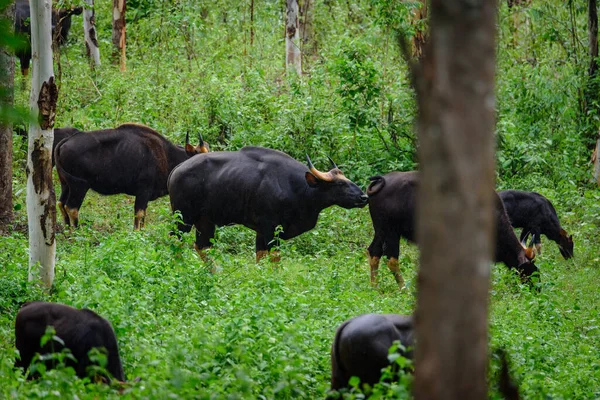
15,301 -> 125,381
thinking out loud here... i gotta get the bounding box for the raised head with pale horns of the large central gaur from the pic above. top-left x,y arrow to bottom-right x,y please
305,155 -> 368,208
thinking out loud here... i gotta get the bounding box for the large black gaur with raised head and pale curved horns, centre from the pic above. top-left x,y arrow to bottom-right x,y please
168,147 -> 367,261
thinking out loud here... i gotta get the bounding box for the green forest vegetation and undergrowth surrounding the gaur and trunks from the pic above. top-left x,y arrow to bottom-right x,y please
0,0 -> 600,399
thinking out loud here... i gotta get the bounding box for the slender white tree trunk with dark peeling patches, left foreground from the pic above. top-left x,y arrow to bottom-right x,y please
27,0 -> 58,288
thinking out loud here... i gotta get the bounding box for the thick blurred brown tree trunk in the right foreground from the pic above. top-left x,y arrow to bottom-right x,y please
415,0 -> 497,400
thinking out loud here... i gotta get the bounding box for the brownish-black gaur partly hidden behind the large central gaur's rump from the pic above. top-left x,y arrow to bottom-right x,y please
54,123 -> 208,229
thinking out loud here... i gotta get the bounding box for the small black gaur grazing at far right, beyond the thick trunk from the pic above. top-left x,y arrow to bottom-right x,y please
498,190 -> 573,259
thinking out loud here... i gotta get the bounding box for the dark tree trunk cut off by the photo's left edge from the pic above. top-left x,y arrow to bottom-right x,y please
0,1 -> 15,233
